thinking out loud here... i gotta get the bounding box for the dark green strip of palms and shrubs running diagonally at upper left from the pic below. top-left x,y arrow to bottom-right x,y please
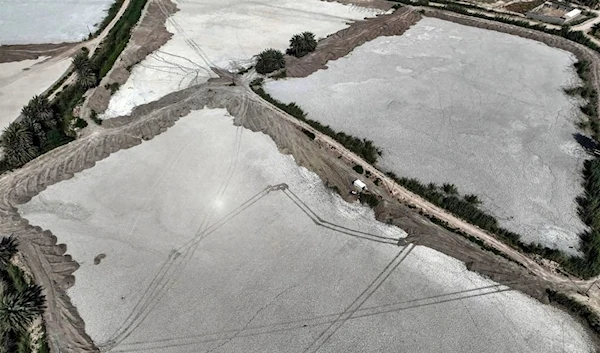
0,0 -> 147,172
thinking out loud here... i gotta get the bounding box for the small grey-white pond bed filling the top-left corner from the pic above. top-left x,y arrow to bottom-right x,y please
0,0 -> 113,44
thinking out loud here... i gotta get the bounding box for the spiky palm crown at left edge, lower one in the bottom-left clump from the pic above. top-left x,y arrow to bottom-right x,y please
0,284 -> 45,332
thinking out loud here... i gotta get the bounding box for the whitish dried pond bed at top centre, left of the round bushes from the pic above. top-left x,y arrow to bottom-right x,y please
104,0 -> 382,118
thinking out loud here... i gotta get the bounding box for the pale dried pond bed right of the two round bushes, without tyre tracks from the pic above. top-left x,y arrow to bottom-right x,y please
266,18 -> 584,252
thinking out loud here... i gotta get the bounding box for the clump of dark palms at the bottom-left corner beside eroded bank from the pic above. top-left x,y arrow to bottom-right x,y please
0,236 -> 45,353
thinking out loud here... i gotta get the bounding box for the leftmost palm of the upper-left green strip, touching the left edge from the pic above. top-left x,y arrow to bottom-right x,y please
0,121 -> 39,167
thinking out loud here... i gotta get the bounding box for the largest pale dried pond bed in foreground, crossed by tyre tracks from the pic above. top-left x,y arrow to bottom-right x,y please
19,109 -> 592,353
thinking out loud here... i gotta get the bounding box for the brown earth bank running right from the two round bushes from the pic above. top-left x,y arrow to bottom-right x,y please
285,7 -> 421,77
